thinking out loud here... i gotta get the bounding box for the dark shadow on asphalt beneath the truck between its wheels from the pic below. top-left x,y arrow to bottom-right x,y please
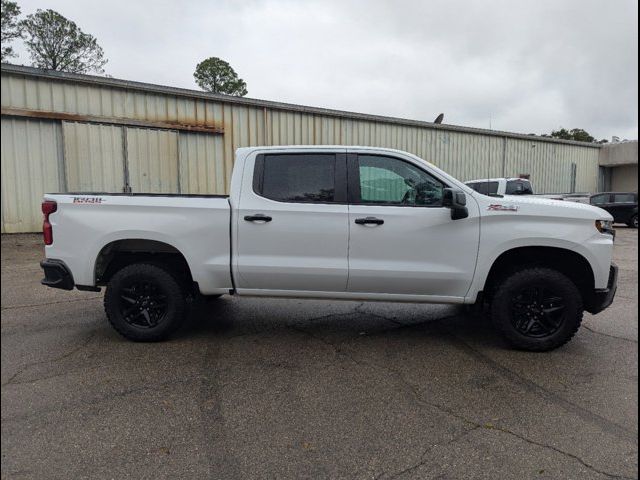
175,297 -> 506,348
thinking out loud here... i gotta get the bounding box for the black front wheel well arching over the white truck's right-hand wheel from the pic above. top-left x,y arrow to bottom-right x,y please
483,247 -> 595,300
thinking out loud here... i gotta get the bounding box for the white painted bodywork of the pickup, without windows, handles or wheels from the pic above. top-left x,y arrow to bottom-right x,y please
38,146 -> 613,303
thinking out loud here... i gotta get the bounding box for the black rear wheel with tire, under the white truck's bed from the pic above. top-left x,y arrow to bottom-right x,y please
104,263 -> 185,342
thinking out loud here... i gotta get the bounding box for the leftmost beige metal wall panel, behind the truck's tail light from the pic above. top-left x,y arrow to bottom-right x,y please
1,118 -> 62,233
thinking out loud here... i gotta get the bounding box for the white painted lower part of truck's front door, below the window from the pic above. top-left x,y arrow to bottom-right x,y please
348,204 -> 480,297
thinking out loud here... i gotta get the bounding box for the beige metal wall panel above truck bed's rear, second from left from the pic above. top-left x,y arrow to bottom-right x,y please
62,122 -> 124,192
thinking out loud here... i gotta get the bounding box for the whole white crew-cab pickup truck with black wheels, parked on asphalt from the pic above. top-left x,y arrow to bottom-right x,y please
41,146 -> 617,351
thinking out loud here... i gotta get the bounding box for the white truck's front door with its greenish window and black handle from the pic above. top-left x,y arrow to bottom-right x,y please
348,154 -> 479,297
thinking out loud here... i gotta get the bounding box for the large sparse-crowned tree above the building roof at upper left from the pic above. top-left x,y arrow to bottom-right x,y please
21,10 -> 107,73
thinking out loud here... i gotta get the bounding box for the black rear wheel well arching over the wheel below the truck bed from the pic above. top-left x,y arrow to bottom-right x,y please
94,239 -> 193,285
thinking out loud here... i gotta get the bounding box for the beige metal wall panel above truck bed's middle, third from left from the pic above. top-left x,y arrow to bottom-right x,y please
126,128 -> 180,193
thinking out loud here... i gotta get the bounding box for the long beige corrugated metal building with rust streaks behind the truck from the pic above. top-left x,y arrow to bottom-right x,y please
1,64 -> 600,232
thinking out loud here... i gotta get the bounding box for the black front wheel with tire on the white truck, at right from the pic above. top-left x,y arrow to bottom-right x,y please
491,268 -> 584,352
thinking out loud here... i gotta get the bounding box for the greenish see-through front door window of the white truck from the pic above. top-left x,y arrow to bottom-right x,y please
358,155 -> 444,207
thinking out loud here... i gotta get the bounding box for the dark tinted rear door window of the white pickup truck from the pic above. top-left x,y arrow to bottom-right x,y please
260,154 -> 336,203
